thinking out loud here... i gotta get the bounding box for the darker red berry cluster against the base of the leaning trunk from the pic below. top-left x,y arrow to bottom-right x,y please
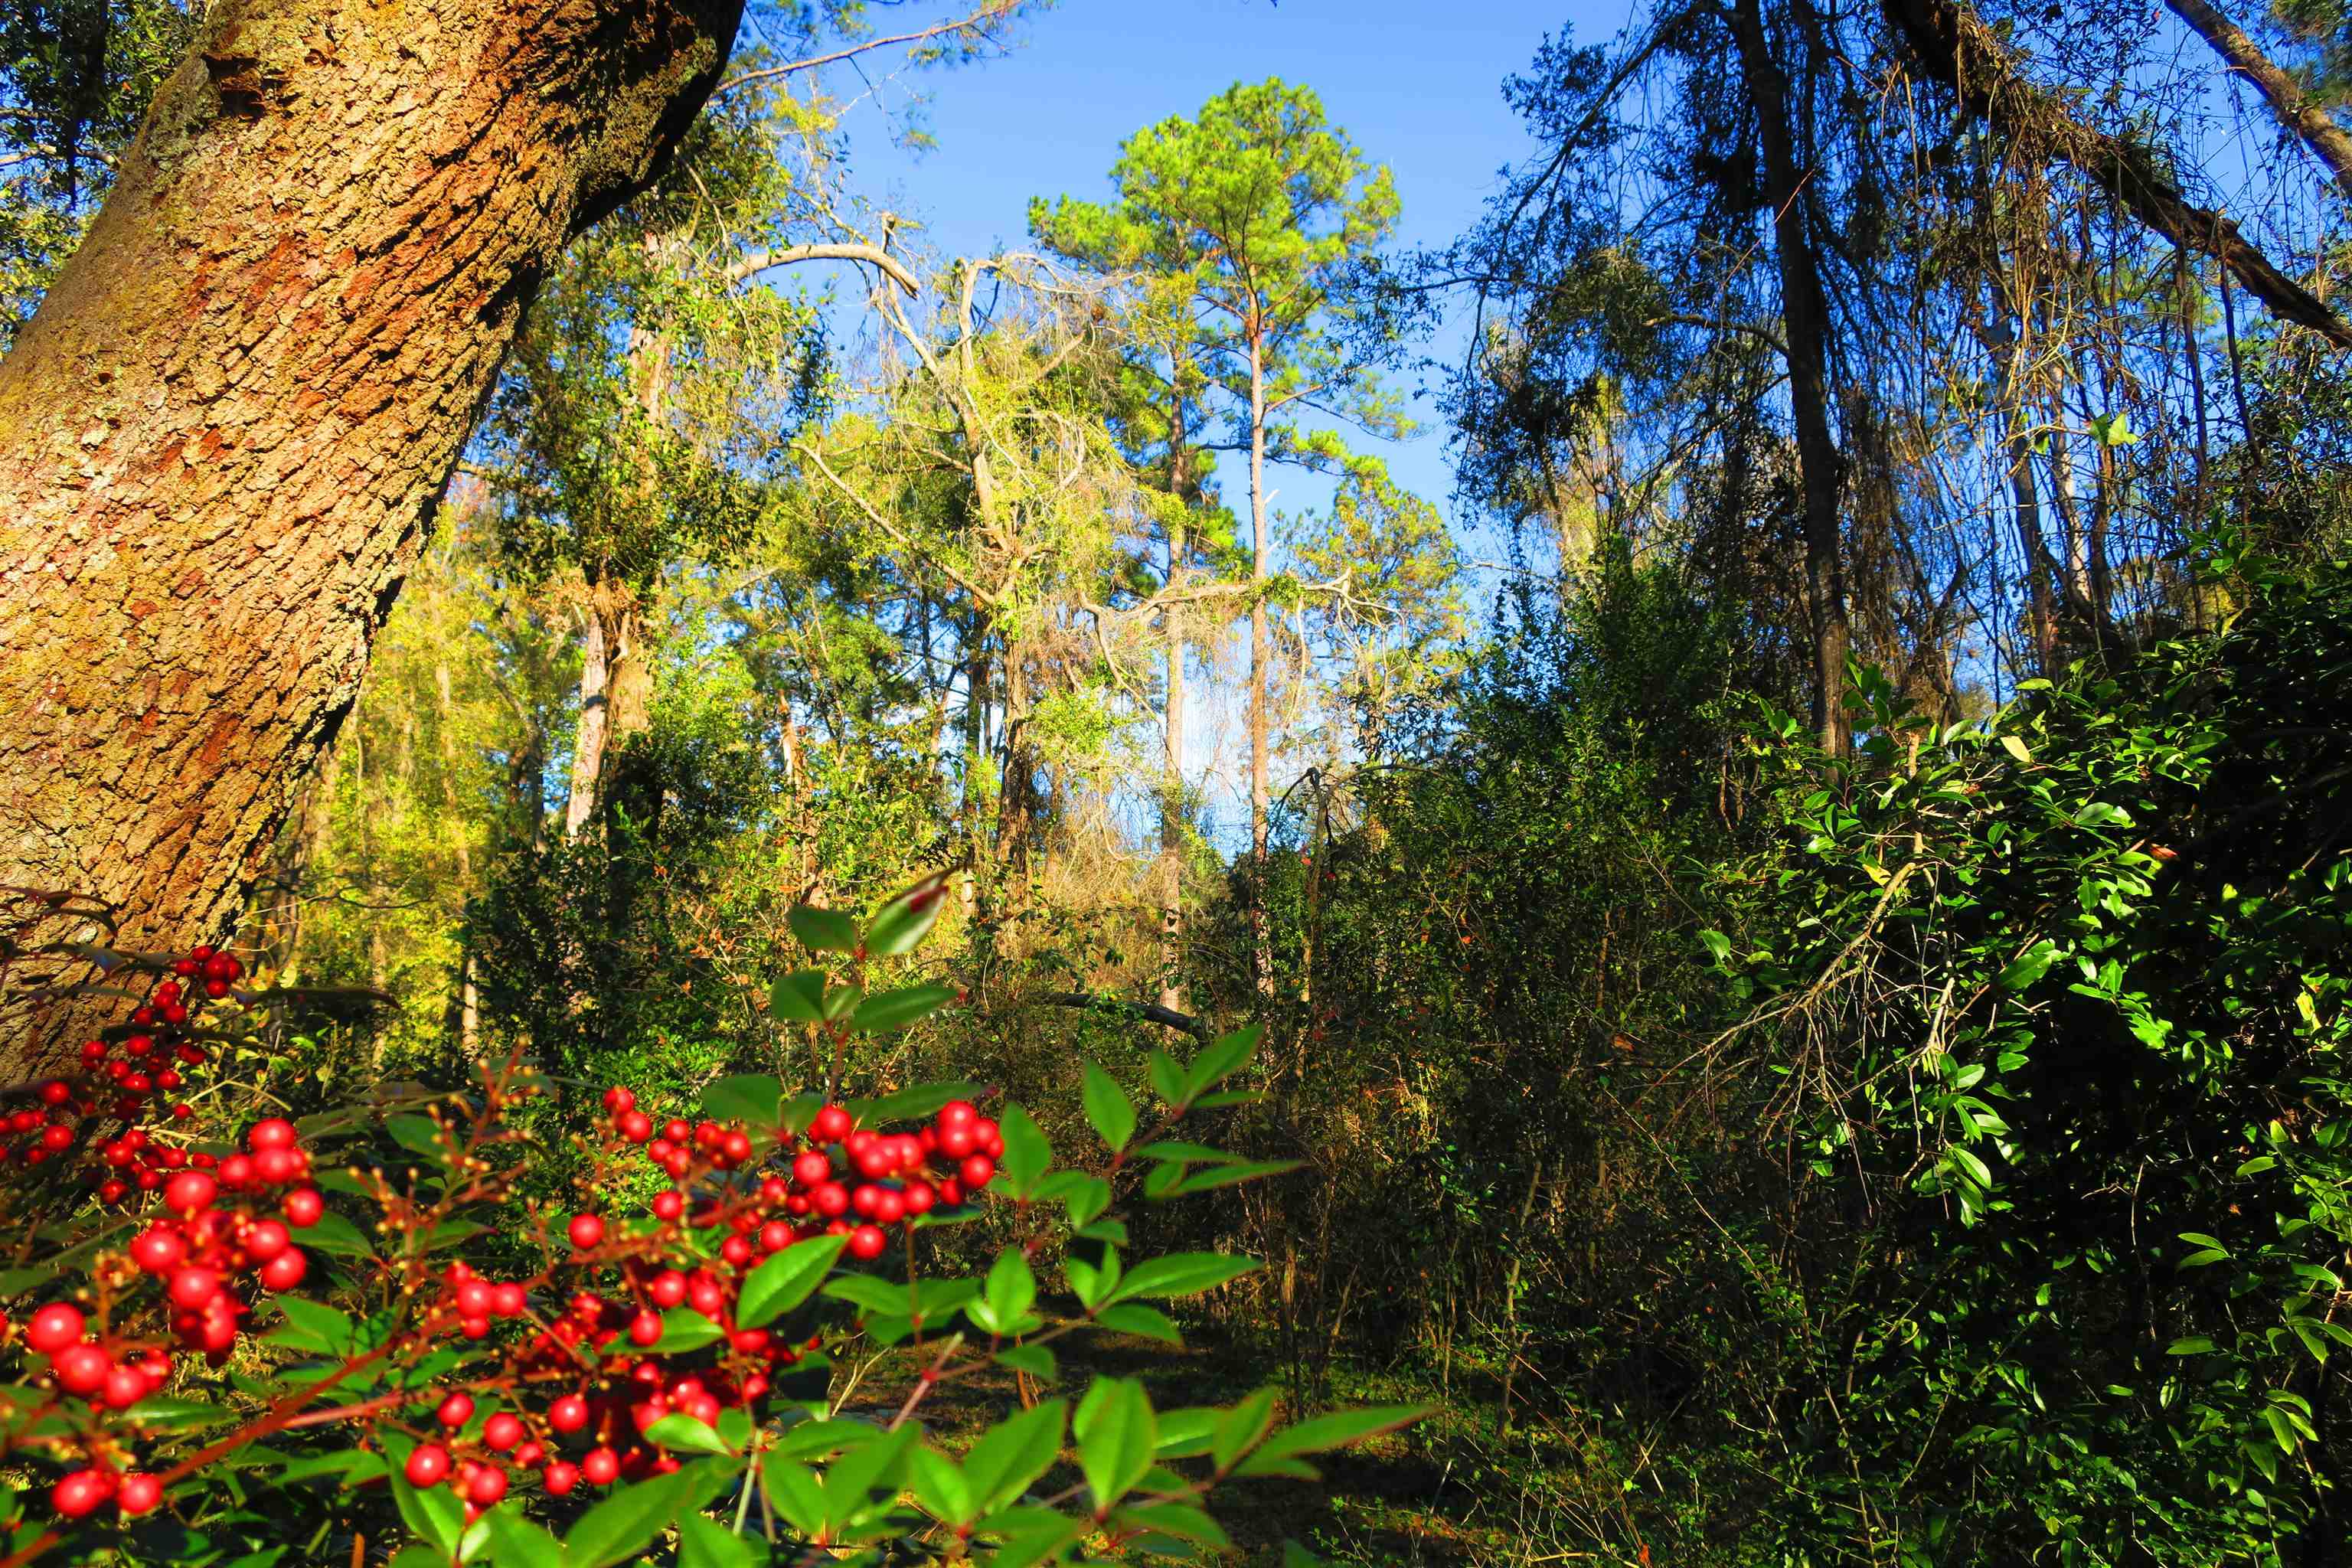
0,945 -> 244,1204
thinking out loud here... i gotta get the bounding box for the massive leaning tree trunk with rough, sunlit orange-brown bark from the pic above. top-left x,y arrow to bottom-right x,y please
0,0 -> 741,1063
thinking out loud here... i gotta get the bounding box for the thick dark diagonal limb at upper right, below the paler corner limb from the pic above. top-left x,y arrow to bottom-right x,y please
1882,0 -> 2352,348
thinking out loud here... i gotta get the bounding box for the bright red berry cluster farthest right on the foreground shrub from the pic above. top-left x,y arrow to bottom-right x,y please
597,1089 -> 1004,1267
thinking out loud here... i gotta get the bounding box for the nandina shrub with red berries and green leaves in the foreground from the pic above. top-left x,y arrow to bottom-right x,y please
0,877 -> 1416,1568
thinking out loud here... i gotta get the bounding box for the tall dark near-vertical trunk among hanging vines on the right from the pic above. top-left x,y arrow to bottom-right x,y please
1731,0 -> 1854,755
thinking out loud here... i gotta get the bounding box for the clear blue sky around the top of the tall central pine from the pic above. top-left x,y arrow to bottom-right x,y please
808,0 -> 1630,543
